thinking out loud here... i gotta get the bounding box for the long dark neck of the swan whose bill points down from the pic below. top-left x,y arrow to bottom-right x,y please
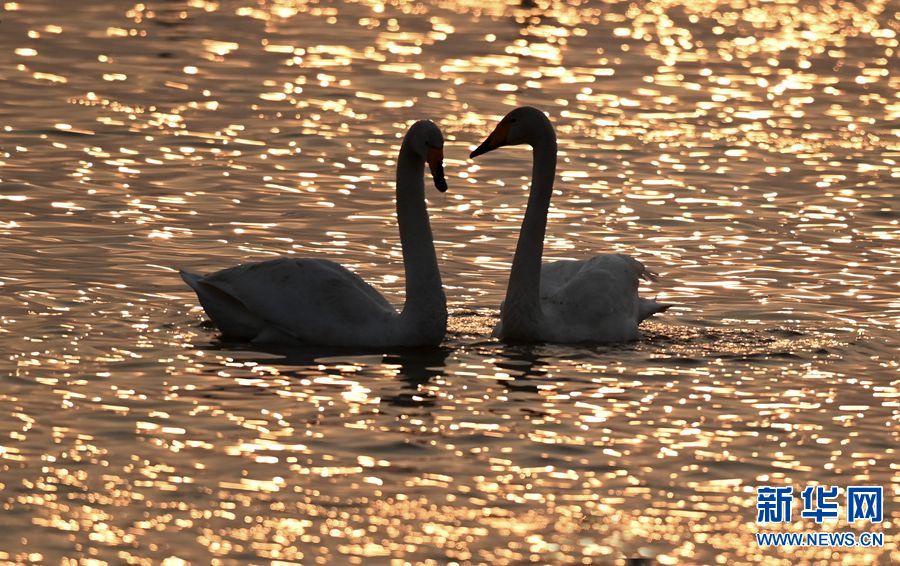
397,140 -> 447,327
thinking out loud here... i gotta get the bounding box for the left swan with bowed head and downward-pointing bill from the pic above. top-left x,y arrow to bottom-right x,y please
180,120 -> 447,347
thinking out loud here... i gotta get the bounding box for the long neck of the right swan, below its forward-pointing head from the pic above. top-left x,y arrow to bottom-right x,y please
502,135 -> 556,332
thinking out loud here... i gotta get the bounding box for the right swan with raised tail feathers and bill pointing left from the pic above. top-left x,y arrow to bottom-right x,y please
470,106 -> 671,343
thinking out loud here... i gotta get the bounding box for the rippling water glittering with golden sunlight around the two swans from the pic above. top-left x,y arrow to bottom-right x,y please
0,0 -> 900,564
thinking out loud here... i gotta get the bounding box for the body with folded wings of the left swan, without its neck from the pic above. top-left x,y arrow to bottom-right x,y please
182,258 -> 396,345
